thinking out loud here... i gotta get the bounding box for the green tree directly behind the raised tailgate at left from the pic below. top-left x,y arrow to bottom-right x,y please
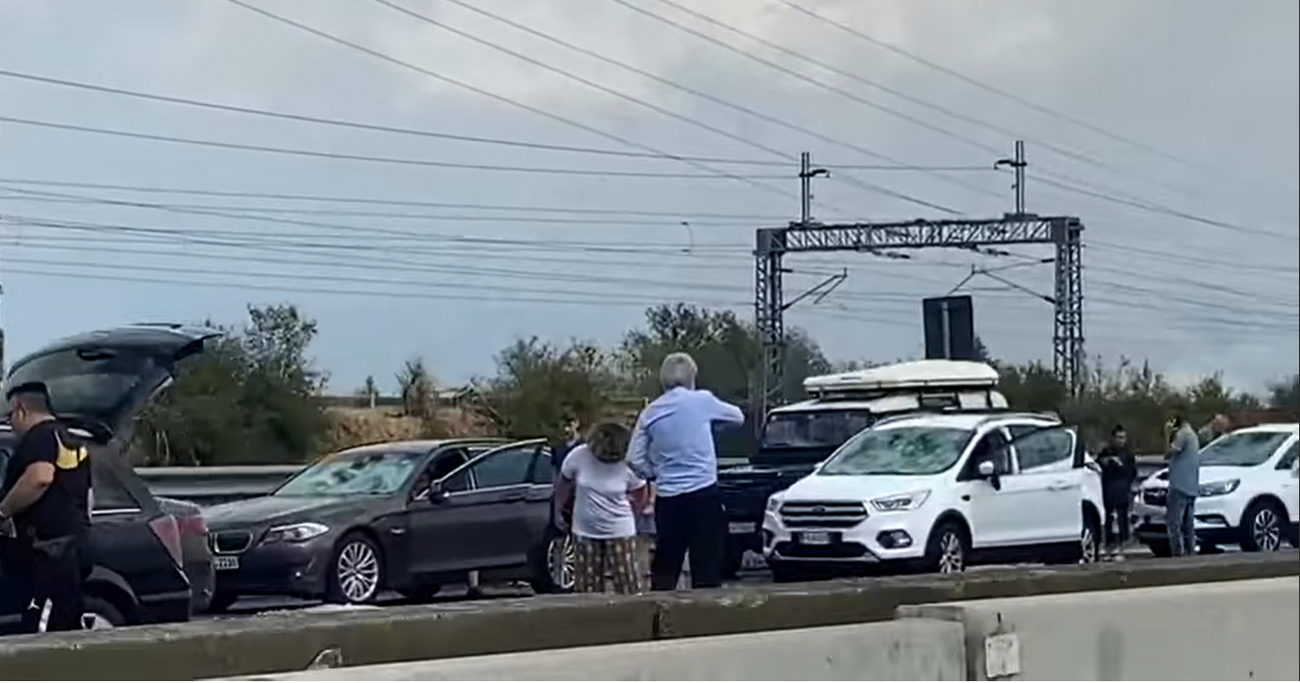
134,304 -> 326,464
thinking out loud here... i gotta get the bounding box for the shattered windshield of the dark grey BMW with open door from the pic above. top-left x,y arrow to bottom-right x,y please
276,453 -> 420,496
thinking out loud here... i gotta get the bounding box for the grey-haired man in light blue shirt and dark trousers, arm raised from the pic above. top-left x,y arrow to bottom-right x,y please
628,353 -> 745,591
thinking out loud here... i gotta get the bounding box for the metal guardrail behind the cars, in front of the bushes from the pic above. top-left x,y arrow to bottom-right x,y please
135,455 -> 1165,506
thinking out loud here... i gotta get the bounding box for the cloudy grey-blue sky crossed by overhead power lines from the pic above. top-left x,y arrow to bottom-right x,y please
0,0 -> 1300,393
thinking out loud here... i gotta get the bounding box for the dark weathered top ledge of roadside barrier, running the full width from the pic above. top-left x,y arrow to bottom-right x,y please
0,552 -> 1300,680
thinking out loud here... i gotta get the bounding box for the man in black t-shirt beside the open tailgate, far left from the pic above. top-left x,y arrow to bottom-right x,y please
0,382 -> 91,632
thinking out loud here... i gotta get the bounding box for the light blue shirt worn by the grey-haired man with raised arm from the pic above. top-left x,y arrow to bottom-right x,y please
628,386 -> 745,498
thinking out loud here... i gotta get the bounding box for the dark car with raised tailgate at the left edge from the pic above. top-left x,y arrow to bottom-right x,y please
0,325 -> 217,634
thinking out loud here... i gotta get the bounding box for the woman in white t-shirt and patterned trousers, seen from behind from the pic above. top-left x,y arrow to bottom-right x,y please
556,423 -> 647,595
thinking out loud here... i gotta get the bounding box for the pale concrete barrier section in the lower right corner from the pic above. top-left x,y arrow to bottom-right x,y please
898,576 -> 1300,680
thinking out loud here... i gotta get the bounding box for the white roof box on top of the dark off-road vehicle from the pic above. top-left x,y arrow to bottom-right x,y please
803,360 -> 997,395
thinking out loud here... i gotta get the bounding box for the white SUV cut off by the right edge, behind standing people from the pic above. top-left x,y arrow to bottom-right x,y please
1132,423 -> 1300,556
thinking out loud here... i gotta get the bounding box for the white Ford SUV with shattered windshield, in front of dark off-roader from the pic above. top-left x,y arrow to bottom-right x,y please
763,412 -> 1102,580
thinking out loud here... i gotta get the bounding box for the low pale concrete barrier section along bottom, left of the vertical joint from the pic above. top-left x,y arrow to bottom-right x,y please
228,619 -> 966,680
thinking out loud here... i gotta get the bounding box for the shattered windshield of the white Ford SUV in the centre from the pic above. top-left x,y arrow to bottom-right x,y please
820,427 -> 971,475
